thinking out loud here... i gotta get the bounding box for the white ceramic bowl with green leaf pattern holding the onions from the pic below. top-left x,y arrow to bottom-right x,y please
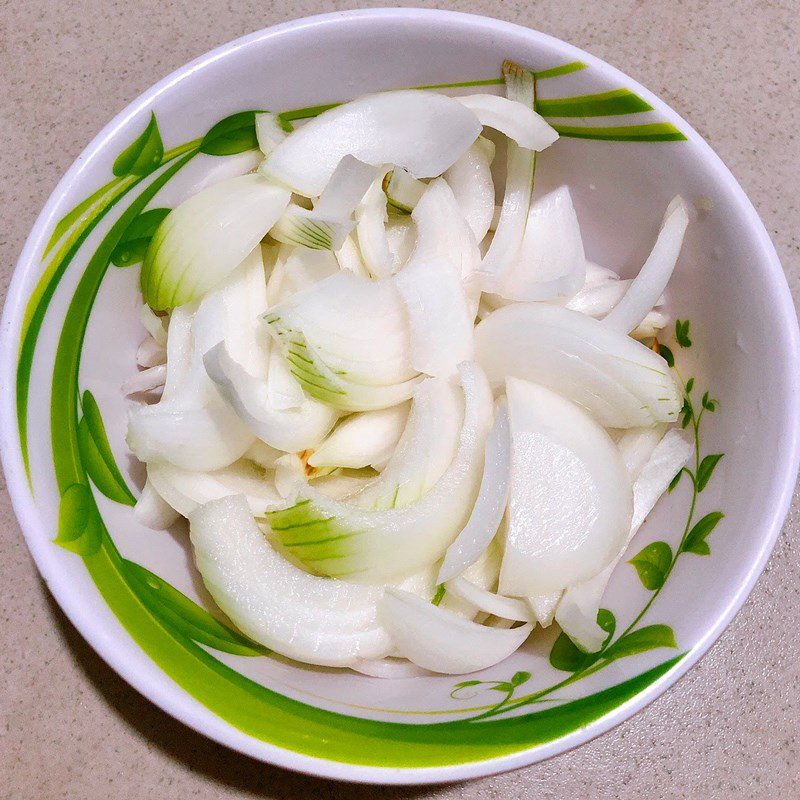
0,9 -> 800,783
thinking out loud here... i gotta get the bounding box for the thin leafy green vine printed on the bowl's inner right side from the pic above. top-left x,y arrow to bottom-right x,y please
450,319 -> 724,722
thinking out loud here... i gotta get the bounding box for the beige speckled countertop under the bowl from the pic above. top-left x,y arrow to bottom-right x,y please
0,0 -> 800,800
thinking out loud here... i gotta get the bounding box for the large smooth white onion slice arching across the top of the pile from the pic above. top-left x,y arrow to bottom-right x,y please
262,90 -> 481,197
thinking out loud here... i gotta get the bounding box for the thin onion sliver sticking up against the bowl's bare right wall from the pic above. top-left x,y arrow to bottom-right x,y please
603,200 -> 689,333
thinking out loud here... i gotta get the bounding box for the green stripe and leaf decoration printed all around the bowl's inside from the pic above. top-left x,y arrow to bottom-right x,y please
9,62 -> 700,766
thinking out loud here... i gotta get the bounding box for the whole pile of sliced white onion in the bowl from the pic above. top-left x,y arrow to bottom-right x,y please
124,63 -> 691,677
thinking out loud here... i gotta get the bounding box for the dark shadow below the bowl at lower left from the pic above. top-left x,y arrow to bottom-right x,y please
40,581 -> 457,800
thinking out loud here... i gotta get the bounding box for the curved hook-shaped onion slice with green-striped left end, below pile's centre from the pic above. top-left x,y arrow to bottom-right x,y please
268,364 -> 491,582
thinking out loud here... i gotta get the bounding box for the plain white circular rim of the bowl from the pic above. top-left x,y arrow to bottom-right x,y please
0,8 -> 800,784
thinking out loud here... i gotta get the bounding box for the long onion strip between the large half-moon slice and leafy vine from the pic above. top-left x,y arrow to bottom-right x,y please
556,430 -> 693,653
